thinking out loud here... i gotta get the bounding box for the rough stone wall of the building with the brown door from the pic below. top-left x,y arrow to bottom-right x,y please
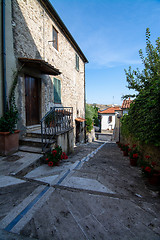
12,0 -> 85,142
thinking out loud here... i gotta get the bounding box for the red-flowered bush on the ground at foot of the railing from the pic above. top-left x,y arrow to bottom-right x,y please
45,145 -> 68,167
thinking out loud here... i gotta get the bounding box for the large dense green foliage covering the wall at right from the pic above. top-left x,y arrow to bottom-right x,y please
121,29 -> 160,146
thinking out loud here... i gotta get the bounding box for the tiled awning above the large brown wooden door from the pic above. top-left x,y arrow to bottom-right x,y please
18,58 -> 61,76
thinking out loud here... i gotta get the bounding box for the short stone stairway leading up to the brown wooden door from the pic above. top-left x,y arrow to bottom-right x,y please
19,125 -> 55,154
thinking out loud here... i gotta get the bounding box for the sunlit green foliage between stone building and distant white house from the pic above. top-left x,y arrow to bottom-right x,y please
86,104 -> 99,132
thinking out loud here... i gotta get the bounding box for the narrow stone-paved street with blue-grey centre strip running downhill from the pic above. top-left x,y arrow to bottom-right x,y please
0,141 -> 160,240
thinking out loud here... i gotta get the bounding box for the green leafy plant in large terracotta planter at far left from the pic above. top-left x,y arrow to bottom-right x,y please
0,106 -> 20,156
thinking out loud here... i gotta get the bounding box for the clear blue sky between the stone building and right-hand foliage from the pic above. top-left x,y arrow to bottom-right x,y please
50,0 -> 160,104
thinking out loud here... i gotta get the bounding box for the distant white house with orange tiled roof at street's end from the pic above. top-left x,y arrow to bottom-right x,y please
98,107 -> 121,131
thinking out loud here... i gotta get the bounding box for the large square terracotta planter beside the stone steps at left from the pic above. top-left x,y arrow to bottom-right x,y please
0,130 -> 20,156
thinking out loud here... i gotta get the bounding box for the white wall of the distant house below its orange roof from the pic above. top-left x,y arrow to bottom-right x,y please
101,113 -> 115,130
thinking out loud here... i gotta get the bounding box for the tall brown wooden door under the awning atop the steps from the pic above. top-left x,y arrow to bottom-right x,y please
25,76 -> 40,126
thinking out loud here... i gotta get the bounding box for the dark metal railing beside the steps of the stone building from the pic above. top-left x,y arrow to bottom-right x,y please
40,107 -> 73,152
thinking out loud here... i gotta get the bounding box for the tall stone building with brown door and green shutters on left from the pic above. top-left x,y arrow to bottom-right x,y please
0,0 -> 88,150
